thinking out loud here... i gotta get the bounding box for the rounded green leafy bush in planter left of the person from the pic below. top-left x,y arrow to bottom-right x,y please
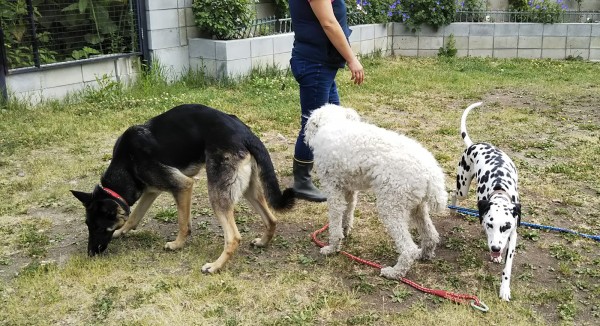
192,0 -> 254,40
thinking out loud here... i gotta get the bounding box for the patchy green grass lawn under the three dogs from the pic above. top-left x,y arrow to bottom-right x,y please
0,57 -> 600,325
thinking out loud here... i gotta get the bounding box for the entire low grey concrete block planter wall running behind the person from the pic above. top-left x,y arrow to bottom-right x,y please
190,23 -> 600,78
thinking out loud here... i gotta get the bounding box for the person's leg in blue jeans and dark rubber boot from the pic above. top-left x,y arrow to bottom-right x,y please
290,58 -> 339,202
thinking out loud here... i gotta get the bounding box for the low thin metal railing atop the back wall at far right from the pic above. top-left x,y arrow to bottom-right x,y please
454,10 -> 600,23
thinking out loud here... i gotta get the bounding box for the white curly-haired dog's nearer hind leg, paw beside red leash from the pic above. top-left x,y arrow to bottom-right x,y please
379,207 -> 421,279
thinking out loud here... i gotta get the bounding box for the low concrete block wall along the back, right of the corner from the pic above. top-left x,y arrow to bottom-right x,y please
391,23 -> 600,61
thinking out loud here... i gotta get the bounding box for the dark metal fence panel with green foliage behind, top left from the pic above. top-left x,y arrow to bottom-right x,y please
0,0 -> 140,70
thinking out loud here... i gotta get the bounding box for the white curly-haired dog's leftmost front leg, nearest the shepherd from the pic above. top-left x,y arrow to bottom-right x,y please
321,190 -> 346,255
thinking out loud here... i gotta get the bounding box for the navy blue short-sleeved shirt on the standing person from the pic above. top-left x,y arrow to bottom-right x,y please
290,0 -> 352,68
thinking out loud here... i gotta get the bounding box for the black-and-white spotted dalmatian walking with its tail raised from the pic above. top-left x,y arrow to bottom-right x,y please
452,102 -> 521,301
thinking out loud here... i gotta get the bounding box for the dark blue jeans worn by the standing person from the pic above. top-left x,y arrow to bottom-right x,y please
290,57 -> 340,163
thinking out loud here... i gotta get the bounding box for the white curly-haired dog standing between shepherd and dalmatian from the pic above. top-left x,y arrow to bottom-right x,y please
305,104 -> 448,279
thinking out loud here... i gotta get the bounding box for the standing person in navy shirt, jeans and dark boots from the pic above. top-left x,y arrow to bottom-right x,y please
289,0 -> 365,202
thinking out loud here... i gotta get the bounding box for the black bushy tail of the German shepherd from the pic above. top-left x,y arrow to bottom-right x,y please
240,134 -> 296,211
